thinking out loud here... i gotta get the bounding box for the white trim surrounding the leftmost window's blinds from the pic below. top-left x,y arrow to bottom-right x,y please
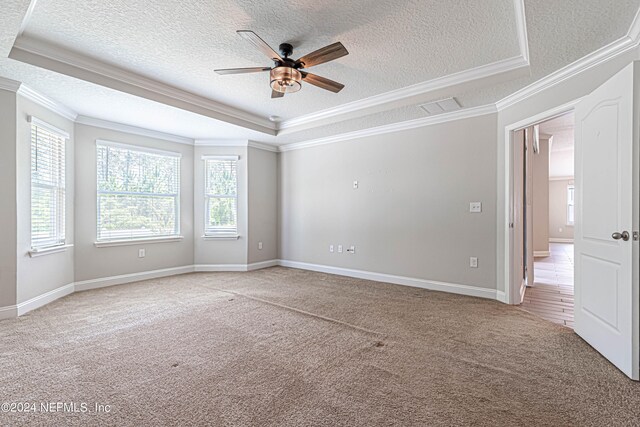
27,115 -> 67,251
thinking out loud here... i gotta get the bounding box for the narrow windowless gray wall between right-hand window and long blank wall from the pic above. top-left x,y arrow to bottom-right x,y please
247,147 -> 278,264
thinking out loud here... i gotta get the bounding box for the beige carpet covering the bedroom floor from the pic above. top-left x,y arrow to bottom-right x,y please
0,267 -> 640,426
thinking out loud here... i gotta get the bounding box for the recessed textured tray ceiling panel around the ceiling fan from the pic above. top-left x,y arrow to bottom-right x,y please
24,0 -> 519,119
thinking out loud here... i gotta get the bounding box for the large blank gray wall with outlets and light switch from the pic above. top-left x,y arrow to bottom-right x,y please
279,114 -> 497,288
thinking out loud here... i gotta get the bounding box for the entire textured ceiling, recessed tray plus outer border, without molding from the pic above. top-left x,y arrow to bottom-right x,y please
0,0 -> 640,144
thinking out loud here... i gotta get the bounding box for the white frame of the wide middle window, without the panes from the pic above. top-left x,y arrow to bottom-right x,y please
94,139 -> 183,242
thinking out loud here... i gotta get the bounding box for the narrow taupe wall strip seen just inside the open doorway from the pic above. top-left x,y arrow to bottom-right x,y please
533,138 -> 549,252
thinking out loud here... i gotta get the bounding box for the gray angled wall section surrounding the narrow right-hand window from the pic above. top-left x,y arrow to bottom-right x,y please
193,146 -> 248,265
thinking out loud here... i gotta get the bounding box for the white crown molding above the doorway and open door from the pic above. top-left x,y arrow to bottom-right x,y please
496,9 -> 640,111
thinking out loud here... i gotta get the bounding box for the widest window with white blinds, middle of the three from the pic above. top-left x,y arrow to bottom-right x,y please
96,141 -> 180,241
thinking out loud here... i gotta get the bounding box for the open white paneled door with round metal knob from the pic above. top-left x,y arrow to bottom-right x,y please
574,64 -> 640,380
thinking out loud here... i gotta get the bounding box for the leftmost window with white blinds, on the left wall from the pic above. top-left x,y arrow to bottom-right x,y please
29,117 -> 69,249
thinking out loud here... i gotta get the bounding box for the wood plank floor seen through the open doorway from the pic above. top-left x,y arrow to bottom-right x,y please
521,243 -> 573,328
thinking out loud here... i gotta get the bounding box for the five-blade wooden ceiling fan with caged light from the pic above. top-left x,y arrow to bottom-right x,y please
214,30 -> 349,98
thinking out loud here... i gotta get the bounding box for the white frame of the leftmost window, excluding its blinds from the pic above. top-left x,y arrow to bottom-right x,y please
27,116 -> 70,254
